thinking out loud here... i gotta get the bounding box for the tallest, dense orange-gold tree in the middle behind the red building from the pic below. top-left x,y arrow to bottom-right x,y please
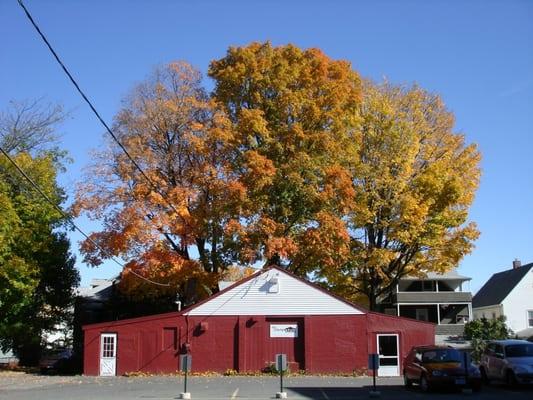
209,43 -> 361,274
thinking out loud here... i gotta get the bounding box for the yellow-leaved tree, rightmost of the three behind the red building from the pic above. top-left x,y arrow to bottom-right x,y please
320,82 -> 480,309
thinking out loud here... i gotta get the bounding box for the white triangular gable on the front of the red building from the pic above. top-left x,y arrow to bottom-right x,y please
184,268 -> 364,316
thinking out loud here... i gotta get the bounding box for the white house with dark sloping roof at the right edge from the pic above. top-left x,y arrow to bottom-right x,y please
472,260 -> 533,335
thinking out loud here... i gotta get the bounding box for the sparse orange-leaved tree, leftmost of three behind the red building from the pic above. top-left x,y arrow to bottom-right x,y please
75,62 -> 240,303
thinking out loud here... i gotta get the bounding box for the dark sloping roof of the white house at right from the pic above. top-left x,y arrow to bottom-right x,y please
472,263 -> 533,308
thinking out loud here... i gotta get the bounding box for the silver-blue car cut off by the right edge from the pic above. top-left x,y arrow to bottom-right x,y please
479,339 -> 533,386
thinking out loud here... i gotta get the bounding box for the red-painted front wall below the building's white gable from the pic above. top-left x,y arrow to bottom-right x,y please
84,313 -> 435,375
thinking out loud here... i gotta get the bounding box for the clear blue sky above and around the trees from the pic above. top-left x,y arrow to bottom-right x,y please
0,0 -> 533,292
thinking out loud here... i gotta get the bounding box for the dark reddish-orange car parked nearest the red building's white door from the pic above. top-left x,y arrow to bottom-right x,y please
403,346 -> 481,392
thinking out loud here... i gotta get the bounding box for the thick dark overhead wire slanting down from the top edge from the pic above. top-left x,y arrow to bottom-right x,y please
17,0 -> 179,219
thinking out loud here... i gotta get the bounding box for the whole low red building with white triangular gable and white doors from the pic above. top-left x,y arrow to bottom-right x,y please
83,267 -> 435,376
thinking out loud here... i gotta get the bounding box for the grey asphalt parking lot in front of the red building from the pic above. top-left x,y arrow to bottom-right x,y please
0,373 -> 533,400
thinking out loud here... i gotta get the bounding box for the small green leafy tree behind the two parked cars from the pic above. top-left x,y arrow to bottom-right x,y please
464,315 -> 513,362
